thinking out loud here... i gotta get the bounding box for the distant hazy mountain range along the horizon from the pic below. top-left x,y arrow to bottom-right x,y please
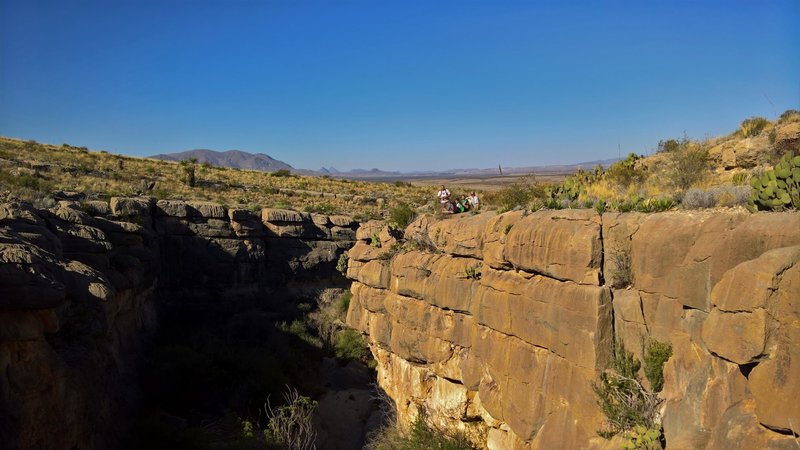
150,149 -> 619,179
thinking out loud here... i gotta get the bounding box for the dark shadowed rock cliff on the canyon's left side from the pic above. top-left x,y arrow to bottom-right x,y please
0,198 -> 356,449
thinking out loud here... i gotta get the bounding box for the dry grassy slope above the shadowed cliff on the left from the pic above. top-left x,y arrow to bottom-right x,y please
0,138 -> 435,218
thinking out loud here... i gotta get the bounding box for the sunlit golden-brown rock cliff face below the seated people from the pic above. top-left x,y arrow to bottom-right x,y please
347,210 -> 800,449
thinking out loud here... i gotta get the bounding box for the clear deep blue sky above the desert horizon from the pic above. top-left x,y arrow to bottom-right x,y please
0,0 -> 800,171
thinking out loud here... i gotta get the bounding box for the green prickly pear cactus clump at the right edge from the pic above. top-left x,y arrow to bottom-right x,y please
748,152 -> 800,211
